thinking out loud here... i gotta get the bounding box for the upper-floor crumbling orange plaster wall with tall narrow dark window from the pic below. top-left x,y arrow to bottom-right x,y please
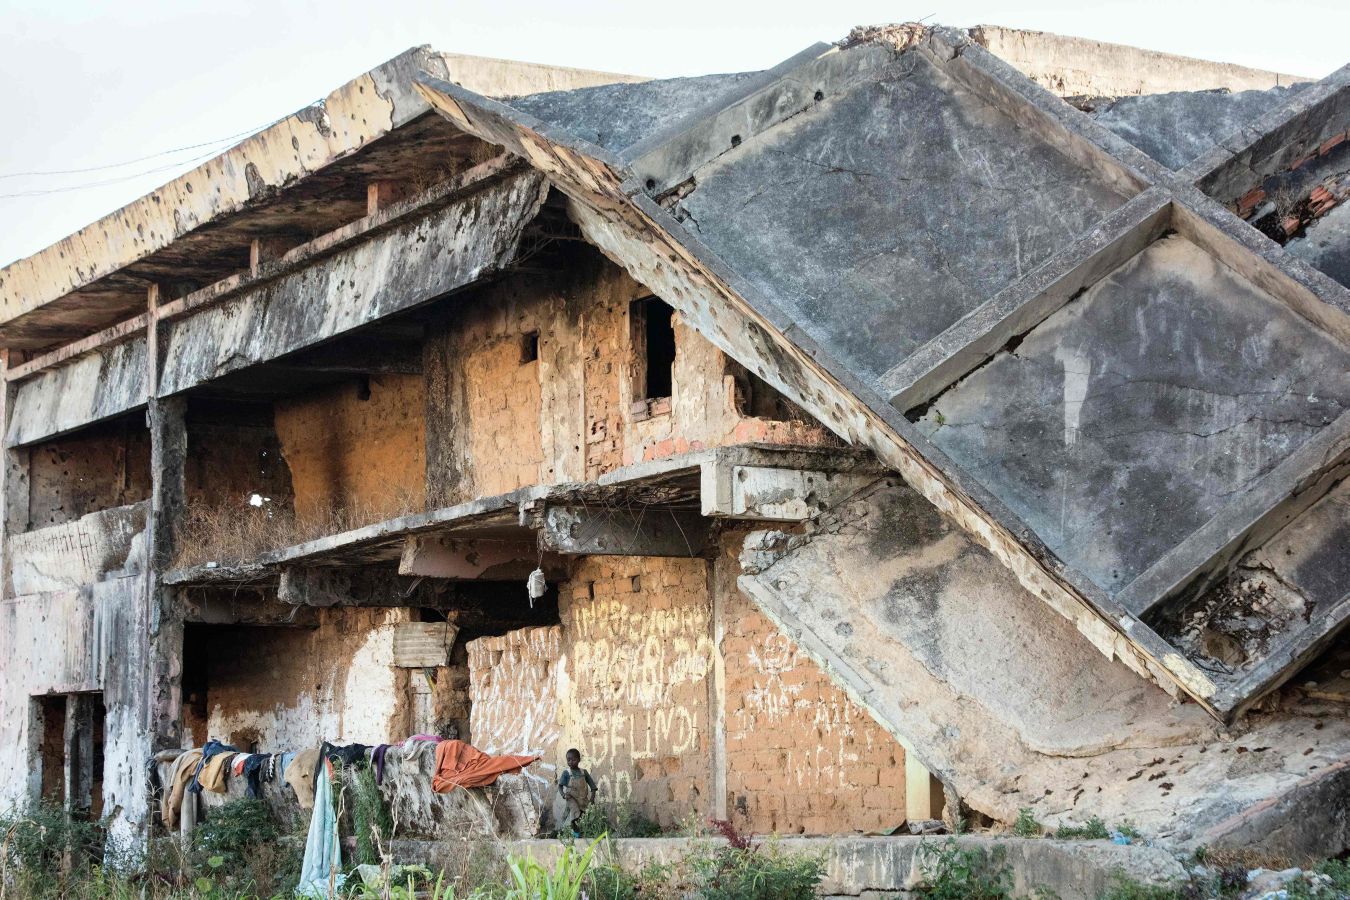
424,252 -> 833,505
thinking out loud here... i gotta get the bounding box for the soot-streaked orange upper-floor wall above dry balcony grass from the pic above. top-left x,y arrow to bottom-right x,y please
277,375 -> 427,522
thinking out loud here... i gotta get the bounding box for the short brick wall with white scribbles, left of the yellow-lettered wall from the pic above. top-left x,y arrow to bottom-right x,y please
466,625 -> 567,766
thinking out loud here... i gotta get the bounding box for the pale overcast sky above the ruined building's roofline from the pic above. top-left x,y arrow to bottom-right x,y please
0,0 -> 1350,264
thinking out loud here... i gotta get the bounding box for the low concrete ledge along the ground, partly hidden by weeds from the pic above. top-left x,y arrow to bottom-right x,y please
508,834 -> 1187,900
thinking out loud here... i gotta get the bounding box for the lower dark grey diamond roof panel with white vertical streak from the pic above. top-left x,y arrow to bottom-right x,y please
921,235 -> 1350,594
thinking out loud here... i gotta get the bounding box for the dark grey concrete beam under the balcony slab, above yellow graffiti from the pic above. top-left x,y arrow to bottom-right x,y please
537,505 -> 710,557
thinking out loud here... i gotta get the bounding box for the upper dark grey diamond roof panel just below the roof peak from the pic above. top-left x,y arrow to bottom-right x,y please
678,51 -> 1125,376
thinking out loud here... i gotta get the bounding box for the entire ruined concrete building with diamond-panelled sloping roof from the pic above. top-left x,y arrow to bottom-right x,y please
0,26 -> 1350,874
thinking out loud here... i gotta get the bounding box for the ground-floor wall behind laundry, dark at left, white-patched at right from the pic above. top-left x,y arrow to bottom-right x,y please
205,607 -> 410,752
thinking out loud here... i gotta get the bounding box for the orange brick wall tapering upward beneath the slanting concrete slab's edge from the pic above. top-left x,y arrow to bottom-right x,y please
716,533 -> 905,834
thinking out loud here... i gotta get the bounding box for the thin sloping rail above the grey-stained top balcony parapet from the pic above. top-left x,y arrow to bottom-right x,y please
7,154 -> 525,391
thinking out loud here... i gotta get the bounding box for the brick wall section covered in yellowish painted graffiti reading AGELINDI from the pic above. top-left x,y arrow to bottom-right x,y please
554,557 -> 713,826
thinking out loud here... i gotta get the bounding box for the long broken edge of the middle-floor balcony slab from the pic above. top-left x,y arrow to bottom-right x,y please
162,444 -> 878,586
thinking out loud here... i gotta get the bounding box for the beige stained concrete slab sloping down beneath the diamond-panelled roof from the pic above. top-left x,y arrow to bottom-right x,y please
738,479 -> 1350,847
